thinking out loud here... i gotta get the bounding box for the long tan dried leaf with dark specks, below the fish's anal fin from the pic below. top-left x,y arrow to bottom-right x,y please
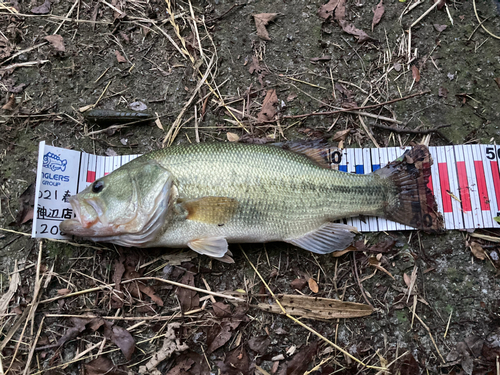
258,294 -> 373,319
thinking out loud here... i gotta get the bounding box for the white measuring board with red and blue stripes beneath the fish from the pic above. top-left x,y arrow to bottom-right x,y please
32,142 -> 500,239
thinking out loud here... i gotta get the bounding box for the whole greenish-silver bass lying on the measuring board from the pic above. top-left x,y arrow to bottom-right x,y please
60,142 -> 443,262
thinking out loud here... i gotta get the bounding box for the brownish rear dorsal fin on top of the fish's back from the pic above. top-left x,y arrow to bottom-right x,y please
273,140 -> 342,169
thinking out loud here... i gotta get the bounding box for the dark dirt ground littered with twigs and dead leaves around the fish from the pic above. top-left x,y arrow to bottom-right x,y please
0,0 -> 500,375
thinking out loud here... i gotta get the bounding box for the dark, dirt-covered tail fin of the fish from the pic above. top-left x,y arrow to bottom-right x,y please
374,145 -> 444,231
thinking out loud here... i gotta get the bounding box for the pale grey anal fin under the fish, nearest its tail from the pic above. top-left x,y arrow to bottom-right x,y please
285,223 -> 357,254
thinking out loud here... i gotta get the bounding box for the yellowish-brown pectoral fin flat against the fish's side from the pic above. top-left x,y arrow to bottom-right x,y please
182,197 -> 238,225
